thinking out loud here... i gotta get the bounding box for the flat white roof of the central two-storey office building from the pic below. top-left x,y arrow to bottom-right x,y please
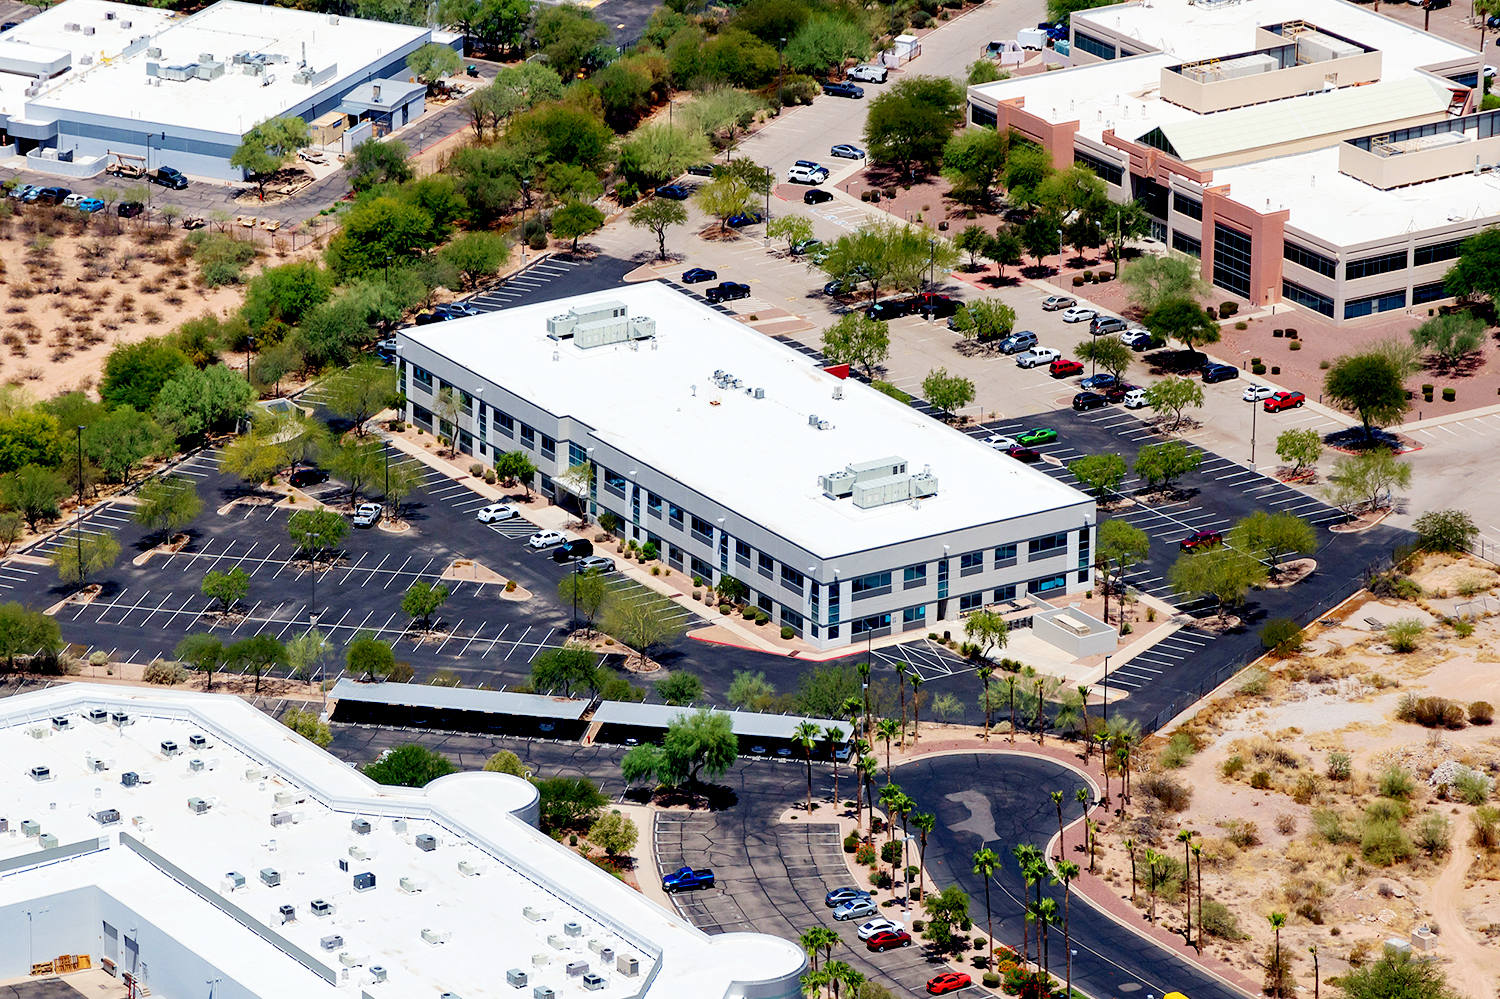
401,282 -> 1089,558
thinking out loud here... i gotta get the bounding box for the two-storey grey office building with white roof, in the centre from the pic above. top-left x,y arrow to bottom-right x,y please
398,282 -> 1095,648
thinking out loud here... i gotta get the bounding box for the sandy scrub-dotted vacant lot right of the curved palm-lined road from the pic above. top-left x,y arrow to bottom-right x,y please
1068,540 -> 1500,996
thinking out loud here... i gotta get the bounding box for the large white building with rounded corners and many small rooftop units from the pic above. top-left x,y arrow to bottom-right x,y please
0,684 -> 804,999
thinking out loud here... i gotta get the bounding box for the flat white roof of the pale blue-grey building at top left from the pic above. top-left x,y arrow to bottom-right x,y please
20,0 -> 428,135
